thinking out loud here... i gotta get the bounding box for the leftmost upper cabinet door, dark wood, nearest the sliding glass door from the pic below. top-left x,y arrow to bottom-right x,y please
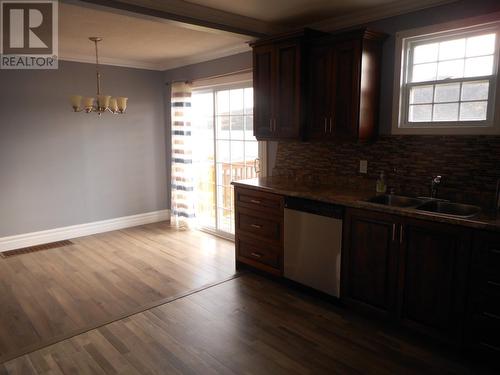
253,45 -> 275,139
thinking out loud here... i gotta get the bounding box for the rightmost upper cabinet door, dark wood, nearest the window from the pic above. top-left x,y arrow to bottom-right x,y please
331,40 -> 361,138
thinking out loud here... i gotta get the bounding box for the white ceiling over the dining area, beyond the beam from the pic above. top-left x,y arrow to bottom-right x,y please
59,3 -> 251,70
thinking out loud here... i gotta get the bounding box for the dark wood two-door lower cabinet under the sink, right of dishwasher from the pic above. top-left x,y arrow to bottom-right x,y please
341,209 -> 471,345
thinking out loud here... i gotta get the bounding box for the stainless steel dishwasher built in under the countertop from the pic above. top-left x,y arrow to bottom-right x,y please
284,197 -> 343,297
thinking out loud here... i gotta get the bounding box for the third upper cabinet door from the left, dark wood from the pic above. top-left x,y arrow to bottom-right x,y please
307,45 -> 334,139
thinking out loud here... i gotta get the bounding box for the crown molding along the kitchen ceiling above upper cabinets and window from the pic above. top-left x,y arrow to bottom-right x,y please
308,0 -> 458,31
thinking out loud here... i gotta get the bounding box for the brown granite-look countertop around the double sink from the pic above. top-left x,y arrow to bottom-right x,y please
232,177 -> 500,232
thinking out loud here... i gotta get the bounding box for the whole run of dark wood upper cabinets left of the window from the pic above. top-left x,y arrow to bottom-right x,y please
251,29 -> 385,140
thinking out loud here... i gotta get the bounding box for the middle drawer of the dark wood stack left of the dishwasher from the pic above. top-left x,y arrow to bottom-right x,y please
236,210 -> 282,242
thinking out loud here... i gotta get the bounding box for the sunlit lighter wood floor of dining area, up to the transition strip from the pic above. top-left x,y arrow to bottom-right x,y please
0,223 -> 235,363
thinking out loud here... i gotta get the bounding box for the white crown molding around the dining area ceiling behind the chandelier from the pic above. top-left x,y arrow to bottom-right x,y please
59,43 -> 251,71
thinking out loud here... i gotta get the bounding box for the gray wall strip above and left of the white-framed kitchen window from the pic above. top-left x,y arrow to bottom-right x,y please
366,0 -> 500,134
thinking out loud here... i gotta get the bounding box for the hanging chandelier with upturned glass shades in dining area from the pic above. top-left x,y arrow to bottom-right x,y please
71,36 -> 128,116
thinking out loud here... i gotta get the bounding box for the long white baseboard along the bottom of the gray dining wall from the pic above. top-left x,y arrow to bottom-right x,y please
0,210 -> 170,252
